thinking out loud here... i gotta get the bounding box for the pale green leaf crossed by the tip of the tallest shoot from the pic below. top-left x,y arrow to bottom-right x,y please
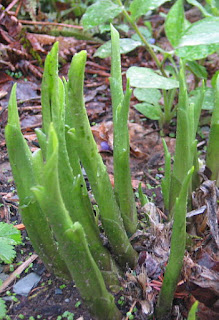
94,38 -> 142,59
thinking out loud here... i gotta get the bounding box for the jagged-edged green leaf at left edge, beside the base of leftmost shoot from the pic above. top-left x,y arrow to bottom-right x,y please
0,222 -> 21,263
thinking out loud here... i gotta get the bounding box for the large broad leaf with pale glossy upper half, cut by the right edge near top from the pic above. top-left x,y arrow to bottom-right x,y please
176,17 -> 219,60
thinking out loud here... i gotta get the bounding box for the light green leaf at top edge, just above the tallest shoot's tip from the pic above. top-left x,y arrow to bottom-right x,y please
82,0 -> 122,30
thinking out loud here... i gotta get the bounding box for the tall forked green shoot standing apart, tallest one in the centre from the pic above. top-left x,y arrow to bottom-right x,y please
110,26 -> 138,235
